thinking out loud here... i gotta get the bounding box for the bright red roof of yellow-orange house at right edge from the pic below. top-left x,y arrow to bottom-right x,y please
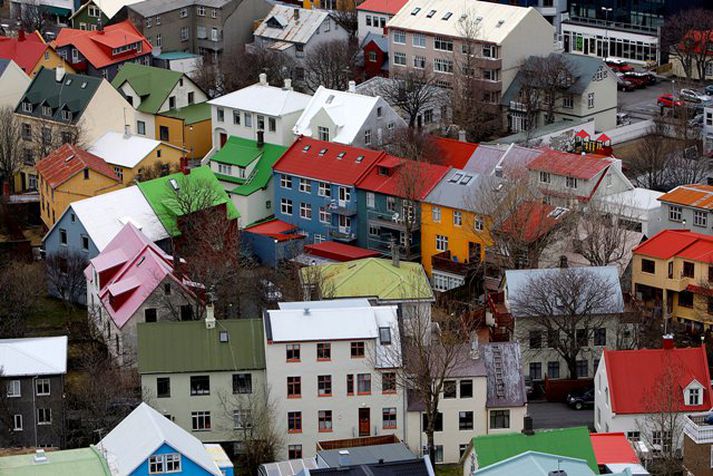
633,230 -> 713,263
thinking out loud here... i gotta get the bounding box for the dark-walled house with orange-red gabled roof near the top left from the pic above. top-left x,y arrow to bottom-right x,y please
53,20 -> 153,81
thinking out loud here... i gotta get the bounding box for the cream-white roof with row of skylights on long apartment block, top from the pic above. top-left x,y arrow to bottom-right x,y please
386,0 -> 545,44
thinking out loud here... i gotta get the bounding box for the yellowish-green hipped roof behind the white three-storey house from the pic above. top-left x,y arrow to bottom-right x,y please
300,258 -> 433,301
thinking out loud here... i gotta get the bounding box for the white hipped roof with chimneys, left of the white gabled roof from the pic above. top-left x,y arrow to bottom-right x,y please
208,83 -> 312,117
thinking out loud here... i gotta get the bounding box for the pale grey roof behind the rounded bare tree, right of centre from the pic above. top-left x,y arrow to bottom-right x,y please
505,266 -> 624,317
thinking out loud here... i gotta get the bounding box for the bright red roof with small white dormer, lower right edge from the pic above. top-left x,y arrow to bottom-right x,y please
602,345 -> 711,414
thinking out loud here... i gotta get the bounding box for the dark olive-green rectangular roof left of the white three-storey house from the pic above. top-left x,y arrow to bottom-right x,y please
138,319 -> 265,373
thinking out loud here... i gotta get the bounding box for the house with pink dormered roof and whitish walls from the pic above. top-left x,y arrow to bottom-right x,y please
84,222 -> 199,368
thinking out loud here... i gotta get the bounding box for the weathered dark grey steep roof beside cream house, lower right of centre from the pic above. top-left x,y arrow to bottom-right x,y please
480,342 -> 527,408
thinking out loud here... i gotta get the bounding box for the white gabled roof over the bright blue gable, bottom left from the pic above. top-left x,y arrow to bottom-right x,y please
97,403 -> 221,476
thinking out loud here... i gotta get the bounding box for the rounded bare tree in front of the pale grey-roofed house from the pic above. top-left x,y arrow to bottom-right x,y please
510,268 -> 623,379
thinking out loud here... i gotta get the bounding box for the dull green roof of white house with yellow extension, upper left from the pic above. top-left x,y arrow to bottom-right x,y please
111,63 -> 183,114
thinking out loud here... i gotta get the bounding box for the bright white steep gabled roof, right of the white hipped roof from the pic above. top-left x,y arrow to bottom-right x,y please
293,86 -> 380,144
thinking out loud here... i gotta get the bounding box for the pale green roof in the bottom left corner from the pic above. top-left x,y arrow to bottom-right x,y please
0,447 -> 111,476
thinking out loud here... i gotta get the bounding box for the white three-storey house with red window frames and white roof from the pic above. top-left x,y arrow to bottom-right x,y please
264,300 -> 405,459
